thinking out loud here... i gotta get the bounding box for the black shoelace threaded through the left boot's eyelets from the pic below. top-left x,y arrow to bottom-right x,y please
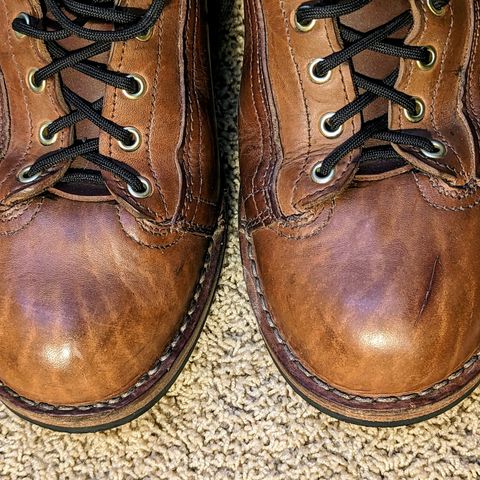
13,0 -> 167,193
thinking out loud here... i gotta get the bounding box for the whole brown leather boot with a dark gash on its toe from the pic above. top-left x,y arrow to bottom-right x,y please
240,0 -> 480,425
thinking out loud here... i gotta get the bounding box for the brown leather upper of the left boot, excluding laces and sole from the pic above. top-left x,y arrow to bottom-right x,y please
0,0 -> 221,405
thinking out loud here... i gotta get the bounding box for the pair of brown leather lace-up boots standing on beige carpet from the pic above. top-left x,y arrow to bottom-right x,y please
0,0 -> 480,431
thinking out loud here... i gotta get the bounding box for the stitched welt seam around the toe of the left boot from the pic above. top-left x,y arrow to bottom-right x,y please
0,214 -> 225,413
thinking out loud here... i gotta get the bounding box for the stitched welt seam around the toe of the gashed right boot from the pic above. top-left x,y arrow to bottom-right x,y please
245,234 -> 480,404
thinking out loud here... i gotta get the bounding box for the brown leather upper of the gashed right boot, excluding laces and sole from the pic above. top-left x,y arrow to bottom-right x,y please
240,0 -> 480,396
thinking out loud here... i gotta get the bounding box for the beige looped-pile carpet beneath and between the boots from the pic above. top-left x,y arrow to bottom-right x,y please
0,1 -> 480,480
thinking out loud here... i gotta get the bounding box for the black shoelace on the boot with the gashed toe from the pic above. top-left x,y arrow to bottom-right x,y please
296,0 -> 450,178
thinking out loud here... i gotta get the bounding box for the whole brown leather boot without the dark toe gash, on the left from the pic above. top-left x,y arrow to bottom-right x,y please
0,0 -> 225,431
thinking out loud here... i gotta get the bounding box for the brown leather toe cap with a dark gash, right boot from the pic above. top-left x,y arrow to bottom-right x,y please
252,174 -> 480,396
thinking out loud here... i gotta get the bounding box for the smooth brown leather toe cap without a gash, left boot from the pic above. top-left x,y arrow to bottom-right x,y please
0,198 -> 209,405
